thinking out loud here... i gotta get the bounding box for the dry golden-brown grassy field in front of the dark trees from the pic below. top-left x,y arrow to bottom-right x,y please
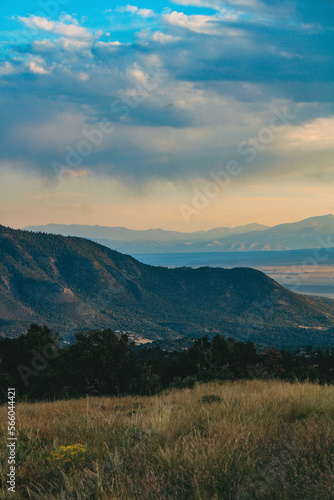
0,381 -> 334,500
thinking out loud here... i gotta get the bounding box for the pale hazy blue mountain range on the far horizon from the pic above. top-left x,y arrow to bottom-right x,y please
26,215 -> 334,255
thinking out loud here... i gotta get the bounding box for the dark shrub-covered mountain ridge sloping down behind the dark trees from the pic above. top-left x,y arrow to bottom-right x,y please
0,226 -> 334,346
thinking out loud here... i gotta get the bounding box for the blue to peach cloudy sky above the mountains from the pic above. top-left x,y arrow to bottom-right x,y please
0,0 -> 334,232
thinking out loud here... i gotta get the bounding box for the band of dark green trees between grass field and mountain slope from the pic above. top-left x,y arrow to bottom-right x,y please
0,325 -> 334,403
